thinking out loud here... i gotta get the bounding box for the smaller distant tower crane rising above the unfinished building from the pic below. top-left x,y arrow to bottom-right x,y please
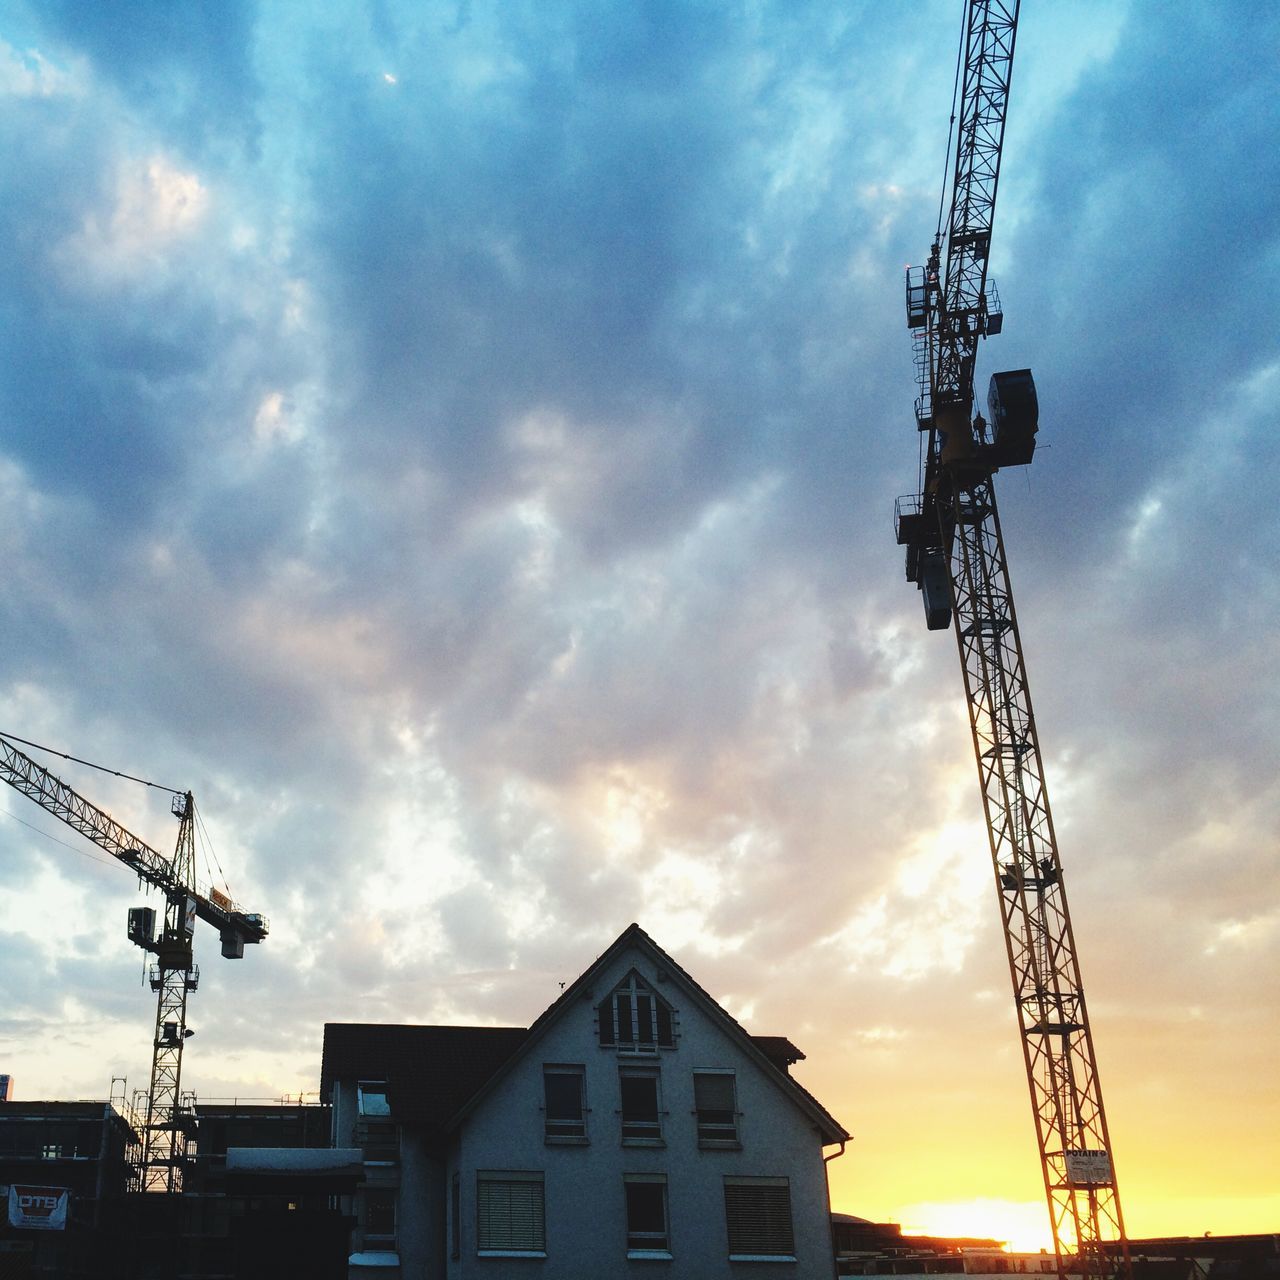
0,735 -> 268,1192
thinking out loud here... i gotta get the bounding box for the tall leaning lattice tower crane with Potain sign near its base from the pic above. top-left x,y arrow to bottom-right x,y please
895,0 -> 1129,1277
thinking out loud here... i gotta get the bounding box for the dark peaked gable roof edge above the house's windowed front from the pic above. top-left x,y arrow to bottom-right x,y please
449,924 -> 849,1146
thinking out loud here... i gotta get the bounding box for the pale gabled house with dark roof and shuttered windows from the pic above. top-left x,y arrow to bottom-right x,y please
321,924 -> 849,1280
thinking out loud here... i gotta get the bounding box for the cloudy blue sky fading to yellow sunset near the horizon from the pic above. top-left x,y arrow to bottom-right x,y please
0,0 -> 1280,1244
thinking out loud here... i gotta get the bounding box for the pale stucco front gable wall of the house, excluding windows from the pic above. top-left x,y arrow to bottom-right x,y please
445,950 -> 835,1280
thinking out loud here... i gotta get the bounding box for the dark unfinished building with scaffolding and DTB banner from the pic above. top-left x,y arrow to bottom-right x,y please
0,1096 -> 364,1280
